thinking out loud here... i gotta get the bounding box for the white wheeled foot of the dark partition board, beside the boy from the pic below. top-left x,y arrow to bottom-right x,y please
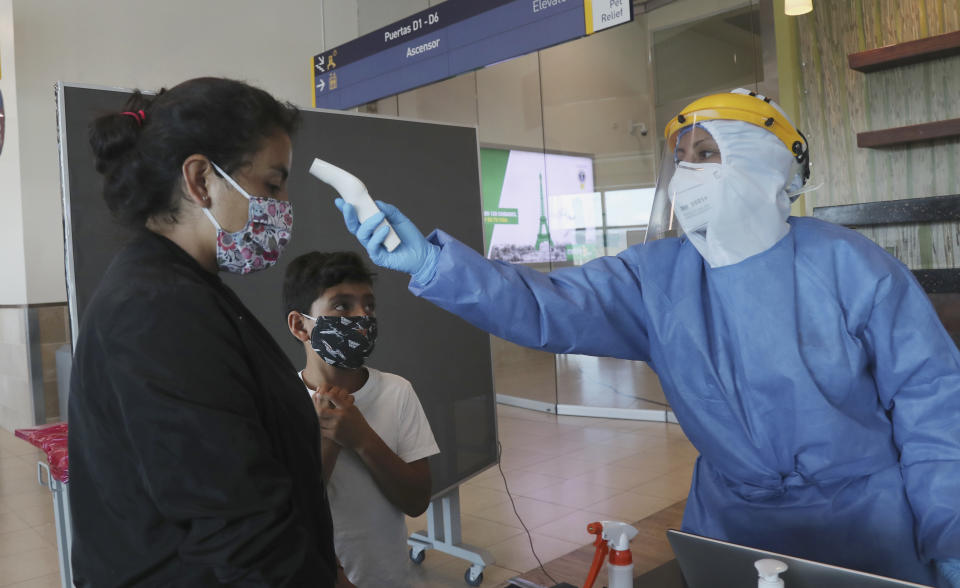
407,486 -> 494,586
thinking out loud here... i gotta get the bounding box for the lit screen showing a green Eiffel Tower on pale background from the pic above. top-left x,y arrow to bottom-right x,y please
480,148 -> 602,263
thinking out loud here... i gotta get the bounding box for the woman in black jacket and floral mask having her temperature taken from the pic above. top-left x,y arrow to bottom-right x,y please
70,78 -> 337,588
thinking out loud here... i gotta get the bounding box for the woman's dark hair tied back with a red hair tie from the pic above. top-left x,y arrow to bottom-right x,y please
89,78 -> 300,226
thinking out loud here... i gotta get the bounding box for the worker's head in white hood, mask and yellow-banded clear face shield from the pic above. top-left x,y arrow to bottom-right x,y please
644,90 -> 809,252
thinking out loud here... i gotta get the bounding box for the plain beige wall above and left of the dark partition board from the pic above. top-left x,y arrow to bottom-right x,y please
6,0 -> 330,305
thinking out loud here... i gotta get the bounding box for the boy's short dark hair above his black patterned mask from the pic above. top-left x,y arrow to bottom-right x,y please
283,251 -> 375,316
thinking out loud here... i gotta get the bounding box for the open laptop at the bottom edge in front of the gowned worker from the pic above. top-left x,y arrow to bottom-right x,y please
667,529 -> 923,588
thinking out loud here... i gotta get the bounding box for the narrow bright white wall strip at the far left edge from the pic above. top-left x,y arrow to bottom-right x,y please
0,0 -> 27,306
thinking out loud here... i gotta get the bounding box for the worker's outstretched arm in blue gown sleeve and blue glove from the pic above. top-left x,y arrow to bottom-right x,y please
337,200 -> 649,360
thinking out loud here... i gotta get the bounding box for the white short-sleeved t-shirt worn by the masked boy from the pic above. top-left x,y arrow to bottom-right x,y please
300,368 -> 440,588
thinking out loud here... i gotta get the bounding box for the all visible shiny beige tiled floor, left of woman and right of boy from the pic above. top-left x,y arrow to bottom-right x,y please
0,406 -> 696,588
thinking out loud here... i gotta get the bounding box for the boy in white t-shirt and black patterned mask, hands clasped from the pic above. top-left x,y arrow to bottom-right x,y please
283,252 -> 440,588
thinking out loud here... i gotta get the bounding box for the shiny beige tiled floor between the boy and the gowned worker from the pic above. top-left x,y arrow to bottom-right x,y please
407,405 -> 697,588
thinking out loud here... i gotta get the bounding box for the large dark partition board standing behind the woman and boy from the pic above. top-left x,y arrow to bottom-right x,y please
59,86 -> 497,493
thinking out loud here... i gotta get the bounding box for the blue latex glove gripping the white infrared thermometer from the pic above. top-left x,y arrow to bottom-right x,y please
335,198 -> 440,284
